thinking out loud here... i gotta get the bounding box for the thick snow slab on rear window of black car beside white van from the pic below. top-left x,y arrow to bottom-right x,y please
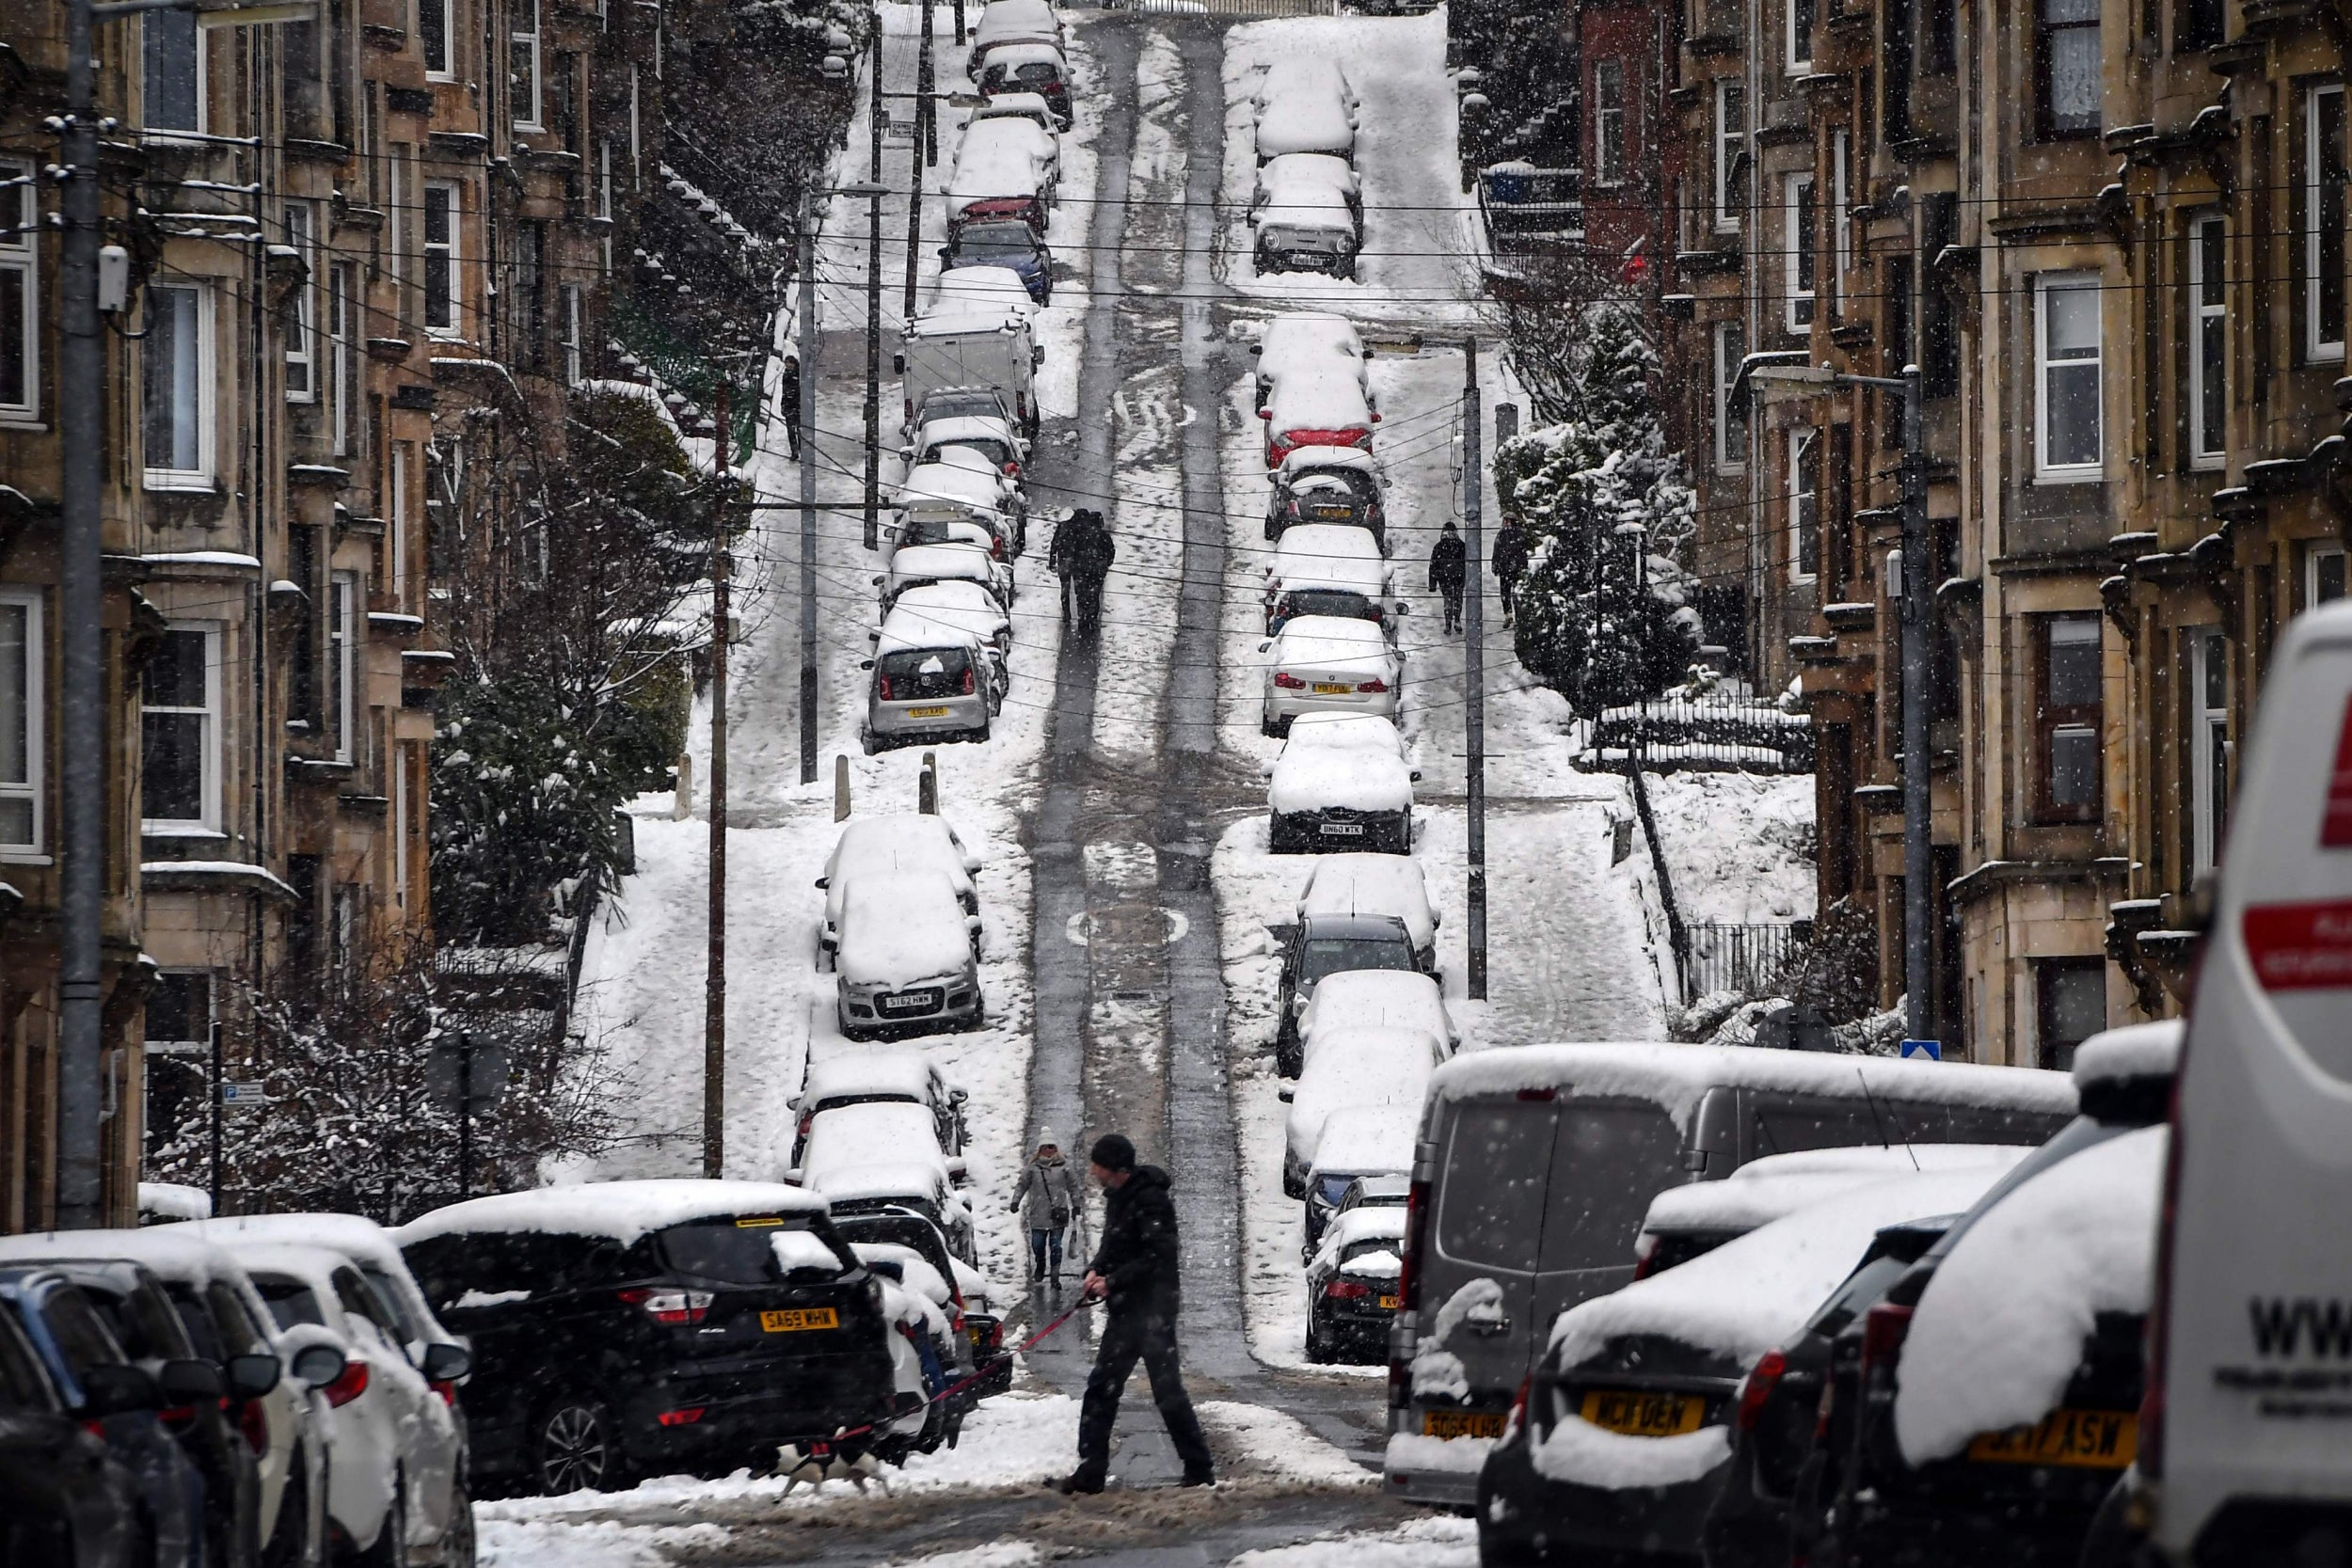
1891,1126 -> 2169,1465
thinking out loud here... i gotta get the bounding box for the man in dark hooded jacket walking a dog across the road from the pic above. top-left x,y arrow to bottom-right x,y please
1061,1133 -> 1216,1493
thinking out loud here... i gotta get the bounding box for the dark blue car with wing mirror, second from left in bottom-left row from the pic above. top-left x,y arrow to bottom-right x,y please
0,1265 -> 208,1568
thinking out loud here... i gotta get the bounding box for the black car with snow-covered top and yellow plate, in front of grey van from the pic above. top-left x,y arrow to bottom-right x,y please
1468,1166 -> 1999,1563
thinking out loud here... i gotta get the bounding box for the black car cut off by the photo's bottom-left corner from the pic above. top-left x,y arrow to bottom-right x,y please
0,1312 -> 149,1568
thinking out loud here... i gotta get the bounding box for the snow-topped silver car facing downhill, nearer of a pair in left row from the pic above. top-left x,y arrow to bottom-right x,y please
833,870 -> 986,1039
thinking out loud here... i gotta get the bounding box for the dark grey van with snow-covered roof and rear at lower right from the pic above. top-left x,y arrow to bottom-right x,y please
1386,1044 -> 2074,1507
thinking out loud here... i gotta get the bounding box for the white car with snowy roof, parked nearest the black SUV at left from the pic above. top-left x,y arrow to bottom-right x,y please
219,1232 -> 473,1563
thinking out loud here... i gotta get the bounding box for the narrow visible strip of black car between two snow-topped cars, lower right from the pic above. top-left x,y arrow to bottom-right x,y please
1703,1218 -> 1950,1568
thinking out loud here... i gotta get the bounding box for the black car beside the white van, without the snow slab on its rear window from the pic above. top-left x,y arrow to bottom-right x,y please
1790,1046 -> 2171,1568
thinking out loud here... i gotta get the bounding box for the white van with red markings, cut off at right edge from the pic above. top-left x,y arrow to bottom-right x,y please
2140,604 -> 2352,1563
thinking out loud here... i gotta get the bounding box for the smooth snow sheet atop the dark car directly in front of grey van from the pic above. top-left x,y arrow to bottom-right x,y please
1550,1166 -> 2002,1369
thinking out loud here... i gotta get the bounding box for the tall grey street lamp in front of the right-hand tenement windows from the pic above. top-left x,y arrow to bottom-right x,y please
1731,355 -> 1941,1055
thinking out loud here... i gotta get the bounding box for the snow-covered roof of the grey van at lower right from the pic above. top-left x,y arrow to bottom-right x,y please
1430,1044 -> 2074,1126
